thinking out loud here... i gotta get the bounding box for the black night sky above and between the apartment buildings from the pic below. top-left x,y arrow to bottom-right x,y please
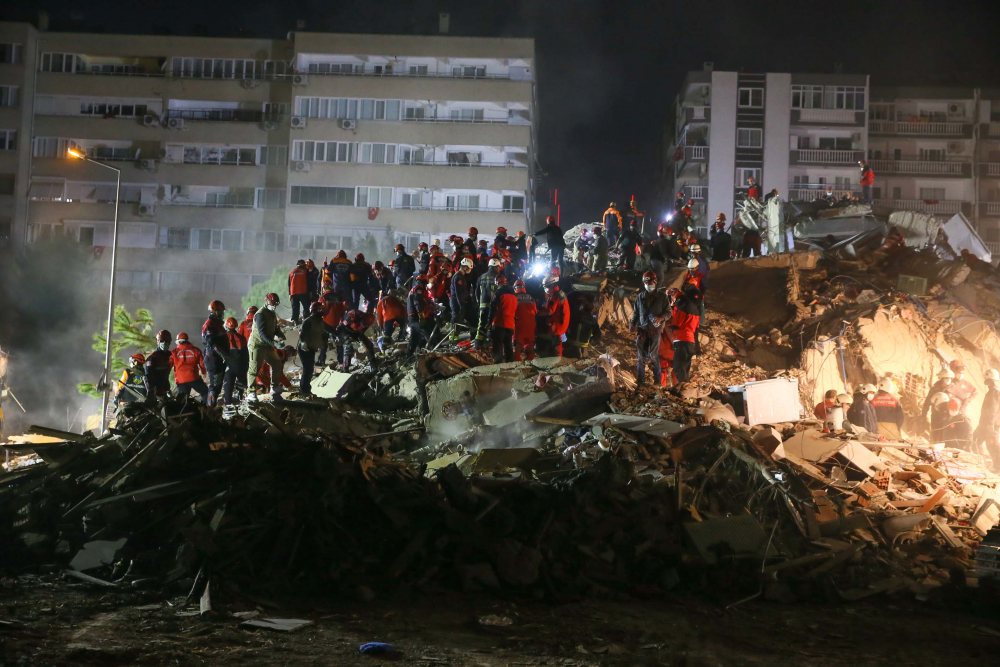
5,0 -> 1000,225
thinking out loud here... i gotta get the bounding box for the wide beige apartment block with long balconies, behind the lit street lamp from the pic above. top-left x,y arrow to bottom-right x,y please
0,23 -> 538,328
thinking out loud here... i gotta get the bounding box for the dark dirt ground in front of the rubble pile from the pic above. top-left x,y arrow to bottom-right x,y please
0,575 -> 1000,667
